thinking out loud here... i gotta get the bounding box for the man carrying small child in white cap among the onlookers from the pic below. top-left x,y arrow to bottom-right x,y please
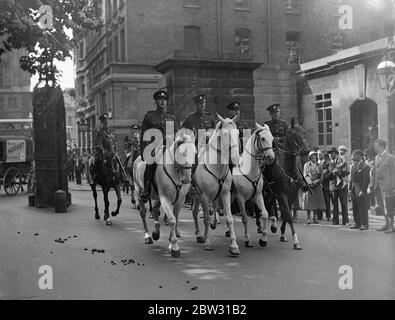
330,148 -> 350,225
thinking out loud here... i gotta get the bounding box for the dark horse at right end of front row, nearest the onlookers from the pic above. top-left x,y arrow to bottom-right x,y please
262,119 -> 309,250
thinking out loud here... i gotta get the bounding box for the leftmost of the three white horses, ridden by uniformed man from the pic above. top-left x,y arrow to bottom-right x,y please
133,130 -> 196,258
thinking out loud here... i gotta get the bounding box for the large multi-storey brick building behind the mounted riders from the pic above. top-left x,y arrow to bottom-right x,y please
75,0 -> 388,153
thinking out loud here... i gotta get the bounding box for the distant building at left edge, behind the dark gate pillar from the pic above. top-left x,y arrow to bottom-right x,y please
0,50 -> 33,135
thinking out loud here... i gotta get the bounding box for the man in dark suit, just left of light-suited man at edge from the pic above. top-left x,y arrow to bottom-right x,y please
350,150 -> 370,230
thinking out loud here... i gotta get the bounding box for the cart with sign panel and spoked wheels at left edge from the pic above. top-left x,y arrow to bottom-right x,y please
0,136 -> 33,196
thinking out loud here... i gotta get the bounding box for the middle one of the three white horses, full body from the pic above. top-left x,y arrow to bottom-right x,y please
192,115 -> 240,256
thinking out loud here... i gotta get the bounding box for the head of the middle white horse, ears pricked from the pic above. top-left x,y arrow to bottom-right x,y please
217,114 -> 240,164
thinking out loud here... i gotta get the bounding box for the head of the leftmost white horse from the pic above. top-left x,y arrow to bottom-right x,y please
174,131 -> 197,184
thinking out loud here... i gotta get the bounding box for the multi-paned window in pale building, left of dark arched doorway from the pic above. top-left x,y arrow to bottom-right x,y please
314,93 -> 333,146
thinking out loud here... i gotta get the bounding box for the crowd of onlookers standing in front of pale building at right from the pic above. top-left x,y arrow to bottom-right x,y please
302,139 -> 395,233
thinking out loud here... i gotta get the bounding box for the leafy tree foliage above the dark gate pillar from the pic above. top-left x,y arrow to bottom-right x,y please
0,0 -> 102,84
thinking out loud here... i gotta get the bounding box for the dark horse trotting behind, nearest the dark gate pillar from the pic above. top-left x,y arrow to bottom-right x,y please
89,155 -> 122,225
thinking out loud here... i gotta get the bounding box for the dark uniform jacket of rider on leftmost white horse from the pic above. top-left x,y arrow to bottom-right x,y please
140,109 -> 178,155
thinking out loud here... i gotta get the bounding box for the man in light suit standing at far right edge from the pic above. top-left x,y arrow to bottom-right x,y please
373,139 -> 395,233
